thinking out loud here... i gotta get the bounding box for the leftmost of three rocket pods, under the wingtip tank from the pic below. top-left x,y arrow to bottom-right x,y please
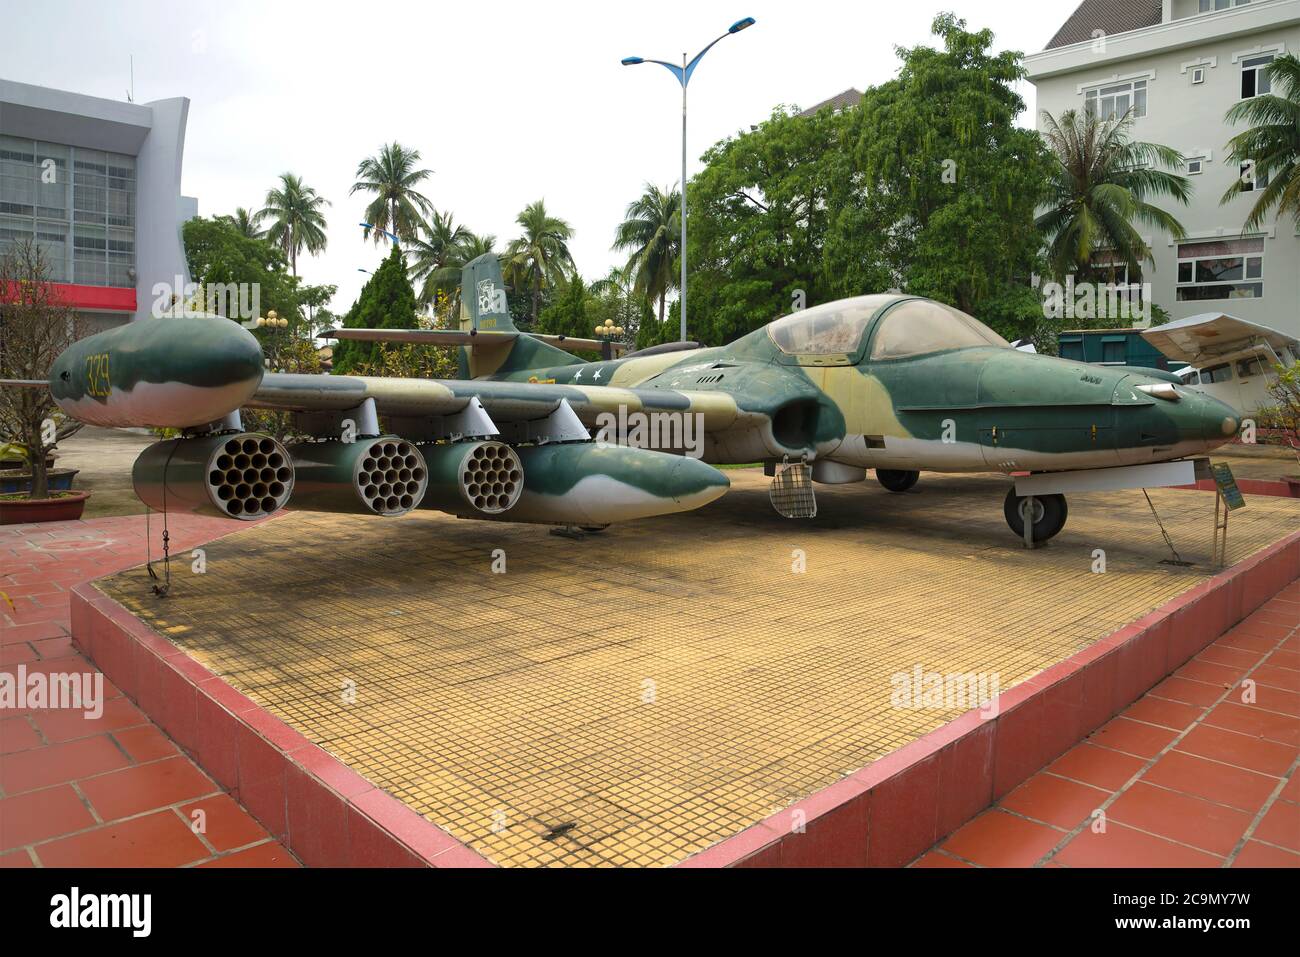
131,432 -> 294,521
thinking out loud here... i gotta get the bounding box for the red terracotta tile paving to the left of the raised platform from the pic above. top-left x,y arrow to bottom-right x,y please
0,518 -> 298,867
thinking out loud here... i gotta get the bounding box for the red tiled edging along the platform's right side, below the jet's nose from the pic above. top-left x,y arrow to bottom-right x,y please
677,532 -> 1300,867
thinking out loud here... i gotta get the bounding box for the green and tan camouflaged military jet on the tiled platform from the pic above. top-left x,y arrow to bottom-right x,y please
38,255 -> 1239,544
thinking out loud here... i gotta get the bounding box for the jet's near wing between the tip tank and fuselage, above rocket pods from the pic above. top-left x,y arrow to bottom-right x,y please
246,372 -> 750,432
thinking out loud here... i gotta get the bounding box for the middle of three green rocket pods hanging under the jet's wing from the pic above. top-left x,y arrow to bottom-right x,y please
289,436 -> 429,518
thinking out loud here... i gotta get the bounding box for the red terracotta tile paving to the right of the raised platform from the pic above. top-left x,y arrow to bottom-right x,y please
915,584 -> 1300,867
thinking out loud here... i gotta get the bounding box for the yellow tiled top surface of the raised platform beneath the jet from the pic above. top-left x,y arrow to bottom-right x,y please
99,471 -> 1300,865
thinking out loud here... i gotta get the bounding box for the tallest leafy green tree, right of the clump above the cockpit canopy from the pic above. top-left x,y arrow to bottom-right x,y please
836,13 -> 1052,317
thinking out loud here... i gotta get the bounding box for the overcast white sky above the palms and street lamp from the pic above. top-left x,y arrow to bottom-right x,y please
0,0 -> 1078,311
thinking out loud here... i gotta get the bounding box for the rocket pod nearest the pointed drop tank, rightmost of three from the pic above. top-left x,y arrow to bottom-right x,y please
423,441 -> 524,519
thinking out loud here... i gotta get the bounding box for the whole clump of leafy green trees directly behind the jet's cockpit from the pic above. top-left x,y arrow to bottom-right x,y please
681,14 -> 1050,345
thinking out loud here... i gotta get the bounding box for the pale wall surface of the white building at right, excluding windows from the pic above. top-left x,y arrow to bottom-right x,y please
1028,0 -> 1300,337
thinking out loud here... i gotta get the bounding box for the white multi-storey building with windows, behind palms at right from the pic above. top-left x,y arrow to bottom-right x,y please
1026,0 -> 1300,335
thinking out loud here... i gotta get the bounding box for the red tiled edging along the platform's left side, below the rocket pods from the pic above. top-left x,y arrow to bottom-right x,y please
72,583 -> 493,867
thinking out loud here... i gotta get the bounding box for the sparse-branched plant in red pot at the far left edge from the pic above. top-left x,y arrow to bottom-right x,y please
0,239 -> 90,525
